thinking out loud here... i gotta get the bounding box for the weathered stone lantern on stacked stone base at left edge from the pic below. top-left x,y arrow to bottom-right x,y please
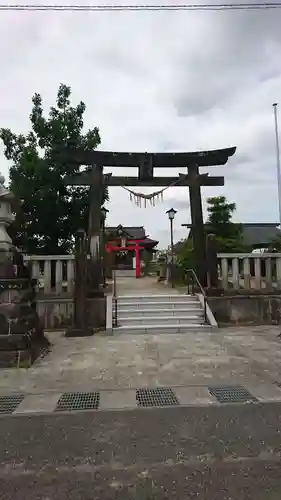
0,175 -> 48,368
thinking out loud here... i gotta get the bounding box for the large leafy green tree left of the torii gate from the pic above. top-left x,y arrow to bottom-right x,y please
0,84 -> 108,254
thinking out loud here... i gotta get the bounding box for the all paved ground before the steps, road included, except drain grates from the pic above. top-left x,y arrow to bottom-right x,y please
0,284 -> 281,500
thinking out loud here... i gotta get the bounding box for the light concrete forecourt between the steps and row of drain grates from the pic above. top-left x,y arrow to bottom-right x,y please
0,326 -> 281,399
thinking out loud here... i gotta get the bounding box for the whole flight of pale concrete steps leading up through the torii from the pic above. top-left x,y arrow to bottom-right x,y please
113,294 -> 211,333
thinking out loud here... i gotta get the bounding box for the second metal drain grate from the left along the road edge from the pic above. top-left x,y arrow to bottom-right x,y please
55,392 -> 100,411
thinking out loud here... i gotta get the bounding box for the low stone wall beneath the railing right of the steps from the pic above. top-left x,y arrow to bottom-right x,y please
208,294 -> 281,325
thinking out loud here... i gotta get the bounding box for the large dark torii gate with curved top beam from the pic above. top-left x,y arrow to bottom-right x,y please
62,147 -> 236,289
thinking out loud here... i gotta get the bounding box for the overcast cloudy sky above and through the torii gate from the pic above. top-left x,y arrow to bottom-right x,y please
0,0 -> 281,247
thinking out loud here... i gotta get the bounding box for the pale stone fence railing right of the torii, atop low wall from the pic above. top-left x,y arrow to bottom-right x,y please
218,253 -> 281,290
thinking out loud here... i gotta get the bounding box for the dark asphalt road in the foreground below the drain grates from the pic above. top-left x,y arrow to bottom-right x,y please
0,403 -> 281,500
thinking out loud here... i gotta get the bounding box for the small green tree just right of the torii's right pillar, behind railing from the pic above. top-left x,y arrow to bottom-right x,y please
206,196 -> 243,252
